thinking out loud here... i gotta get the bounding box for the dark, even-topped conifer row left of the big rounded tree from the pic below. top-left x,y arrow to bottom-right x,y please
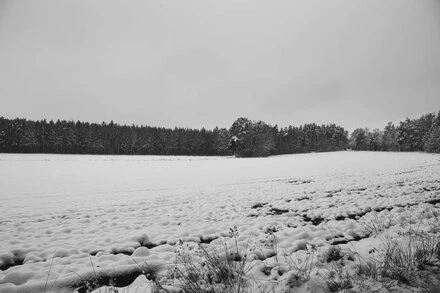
0,117 -> 230,155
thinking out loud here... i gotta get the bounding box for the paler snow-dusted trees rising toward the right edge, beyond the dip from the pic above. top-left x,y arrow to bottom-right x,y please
348,111 -> 440,153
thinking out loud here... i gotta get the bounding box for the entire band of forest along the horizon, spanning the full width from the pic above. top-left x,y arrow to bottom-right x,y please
0,112 -> 440,157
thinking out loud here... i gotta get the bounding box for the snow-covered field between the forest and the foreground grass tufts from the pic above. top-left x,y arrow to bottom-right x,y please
0,151 -> 440,293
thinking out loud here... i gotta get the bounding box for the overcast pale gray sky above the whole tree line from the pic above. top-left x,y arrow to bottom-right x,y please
0,0 -> 440,130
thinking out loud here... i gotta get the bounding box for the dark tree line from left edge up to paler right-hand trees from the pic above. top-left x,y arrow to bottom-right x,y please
0,117 -> 347,157
